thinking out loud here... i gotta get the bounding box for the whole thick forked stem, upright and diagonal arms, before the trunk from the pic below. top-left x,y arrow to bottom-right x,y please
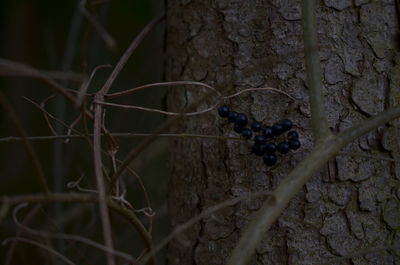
226,0 -> 400,265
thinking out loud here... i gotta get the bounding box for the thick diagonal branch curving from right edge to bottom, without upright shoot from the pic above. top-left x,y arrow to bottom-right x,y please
227,106 -> 400,265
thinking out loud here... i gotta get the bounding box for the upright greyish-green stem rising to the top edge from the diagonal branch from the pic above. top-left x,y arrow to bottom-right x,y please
301,0 -> 331,144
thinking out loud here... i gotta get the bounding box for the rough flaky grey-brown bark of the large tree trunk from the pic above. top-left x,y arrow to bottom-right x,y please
166,0 -> 400,265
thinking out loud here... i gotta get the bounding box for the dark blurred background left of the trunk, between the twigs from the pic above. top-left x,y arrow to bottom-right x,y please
0,0 -> 168,265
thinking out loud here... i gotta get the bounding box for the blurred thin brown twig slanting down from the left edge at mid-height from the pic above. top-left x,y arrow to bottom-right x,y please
0,91 -> 49,194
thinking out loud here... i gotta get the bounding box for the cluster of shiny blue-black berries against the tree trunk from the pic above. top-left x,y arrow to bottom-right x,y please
218,105 -> 300,166
